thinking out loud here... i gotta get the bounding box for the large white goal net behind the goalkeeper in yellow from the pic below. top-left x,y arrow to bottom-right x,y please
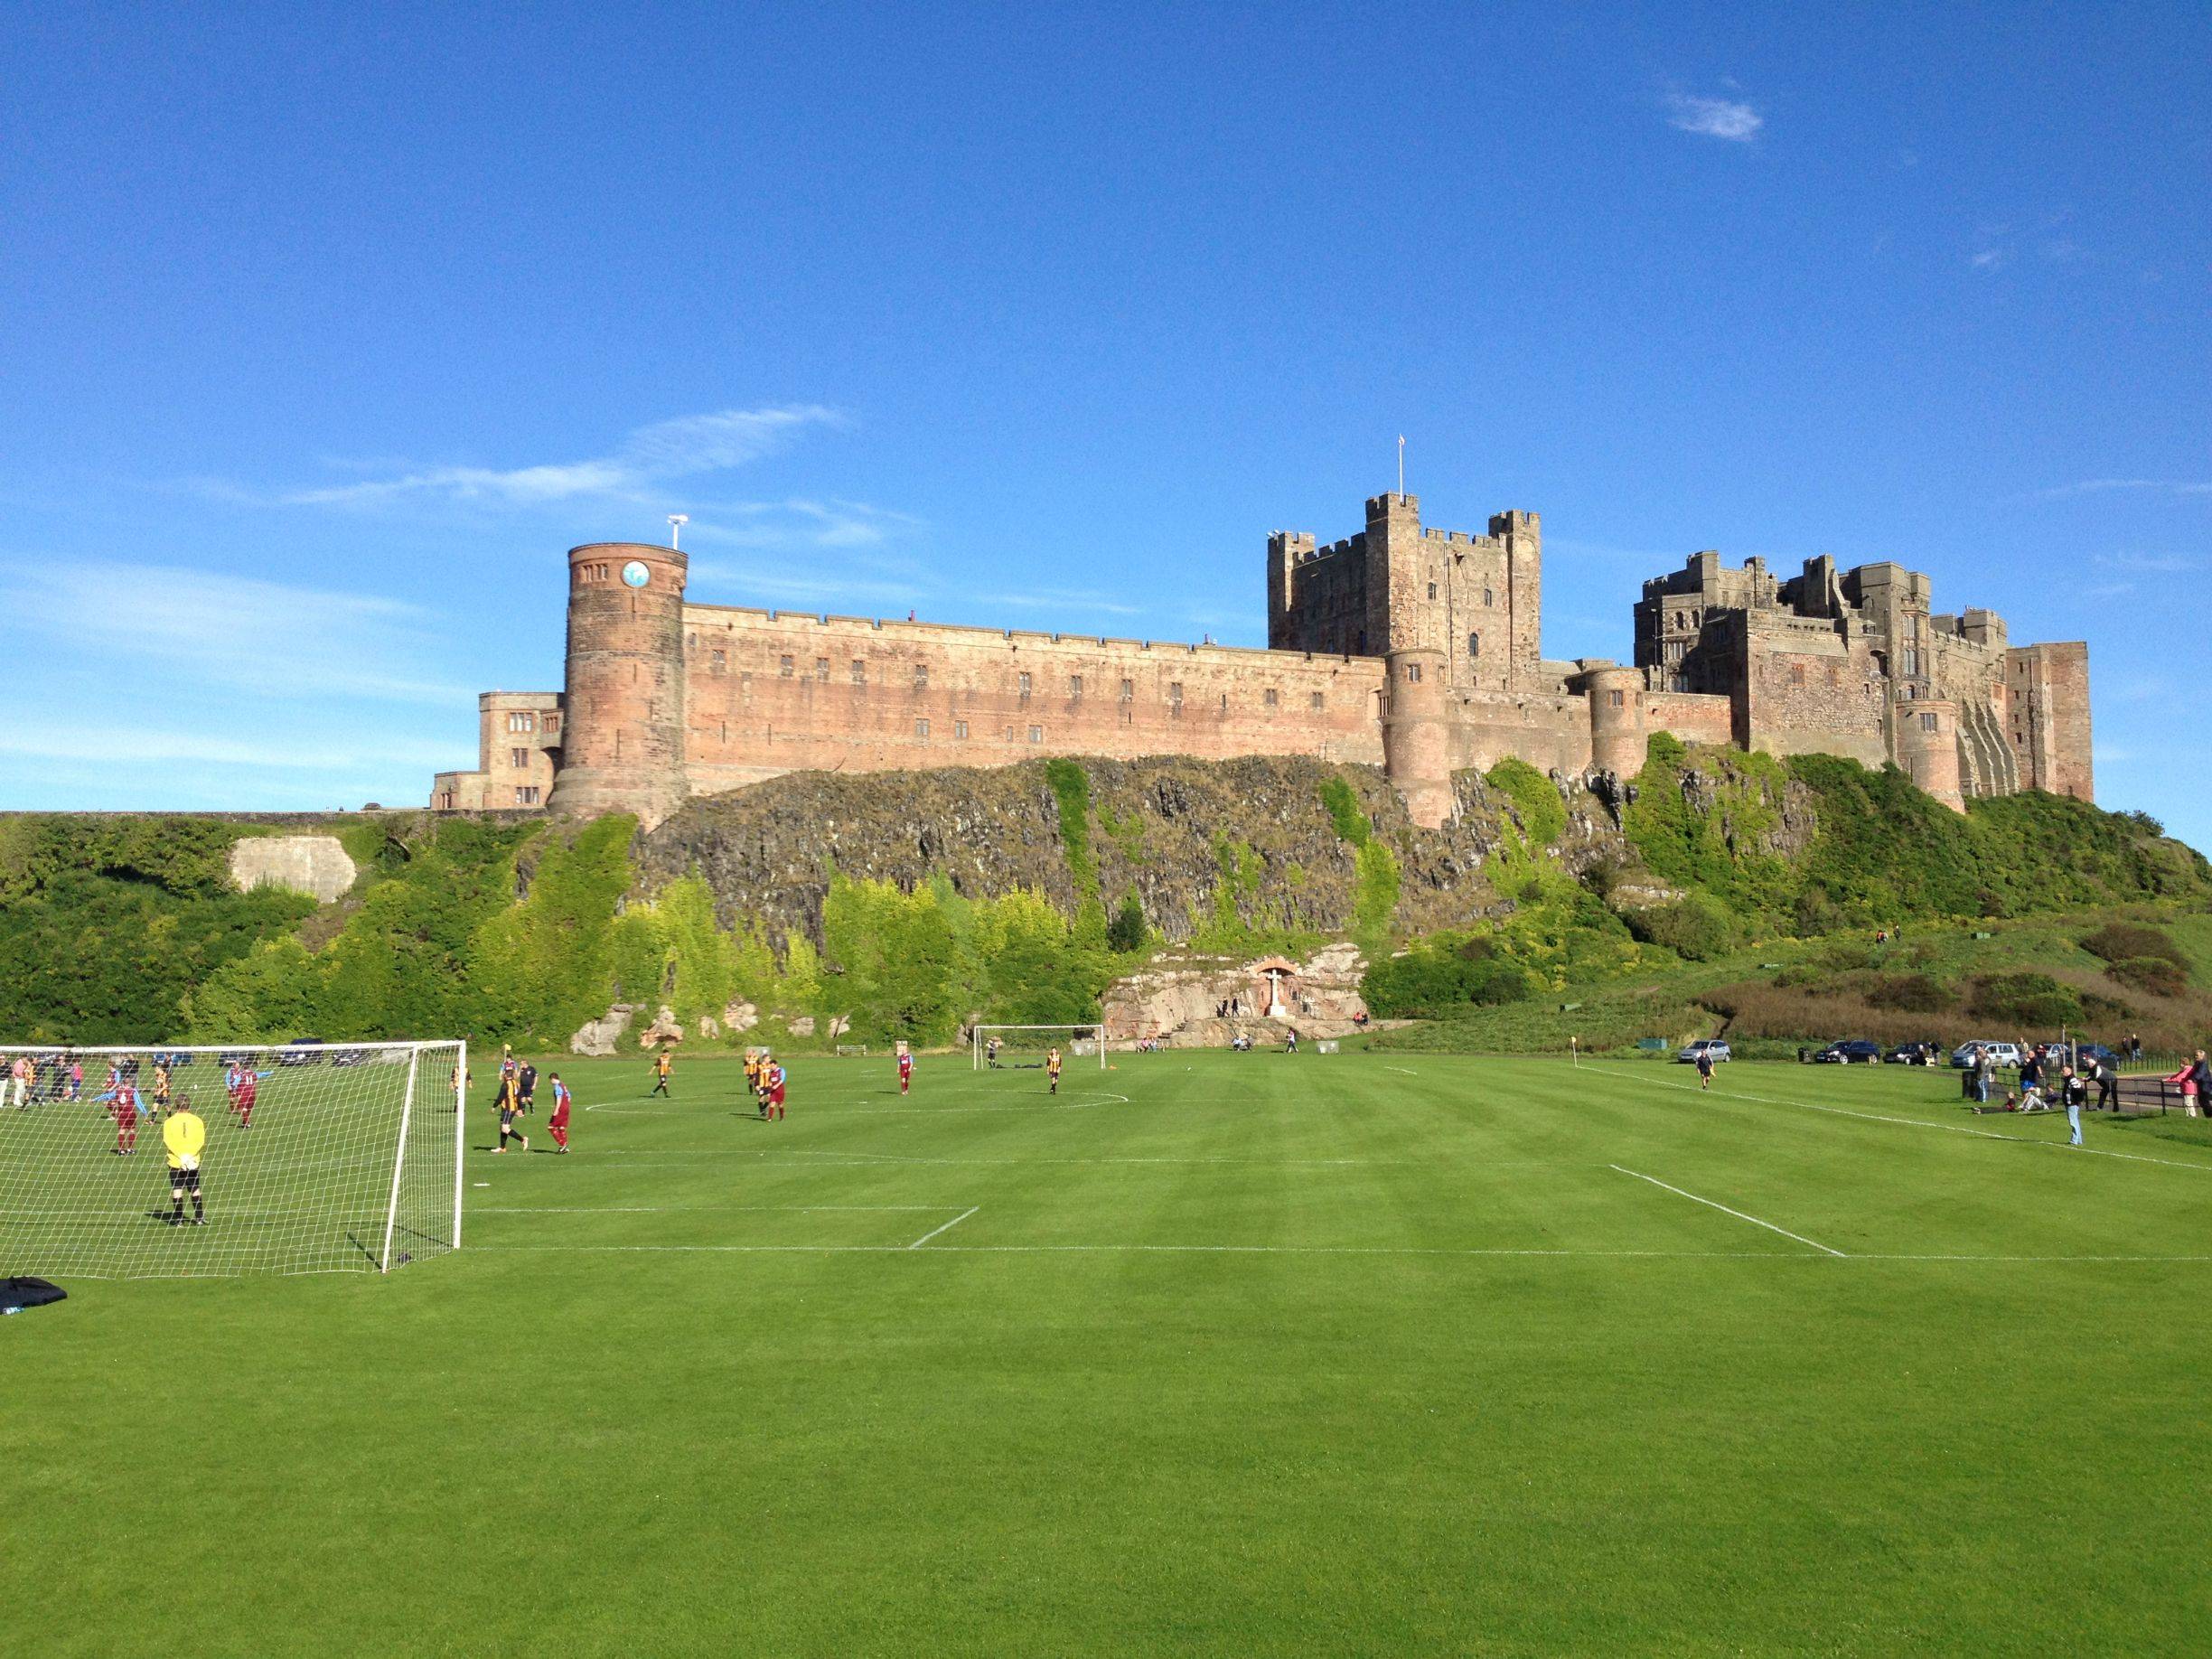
0,1042 -> 467,1279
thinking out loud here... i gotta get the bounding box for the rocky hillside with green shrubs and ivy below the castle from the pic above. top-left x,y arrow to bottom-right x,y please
0,736 -> 2212,1046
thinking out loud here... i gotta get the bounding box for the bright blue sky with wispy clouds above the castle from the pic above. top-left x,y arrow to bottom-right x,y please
0,5 -> 2212,845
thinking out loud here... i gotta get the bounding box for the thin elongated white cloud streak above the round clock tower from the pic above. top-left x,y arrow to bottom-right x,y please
269,403 -> 839,507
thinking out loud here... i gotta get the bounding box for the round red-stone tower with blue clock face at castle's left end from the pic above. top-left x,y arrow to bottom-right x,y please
547,542 -> 688,830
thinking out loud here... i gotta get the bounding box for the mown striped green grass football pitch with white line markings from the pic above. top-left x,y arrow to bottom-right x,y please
0,1053 -> 2212,1657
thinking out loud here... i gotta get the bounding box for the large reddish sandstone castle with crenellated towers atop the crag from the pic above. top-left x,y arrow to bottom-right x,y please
431,493 -> 2093,828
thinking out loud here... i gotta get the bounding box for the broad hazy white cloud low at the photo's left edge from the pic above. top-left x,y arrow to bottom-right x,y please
0,559 -> 469,706
